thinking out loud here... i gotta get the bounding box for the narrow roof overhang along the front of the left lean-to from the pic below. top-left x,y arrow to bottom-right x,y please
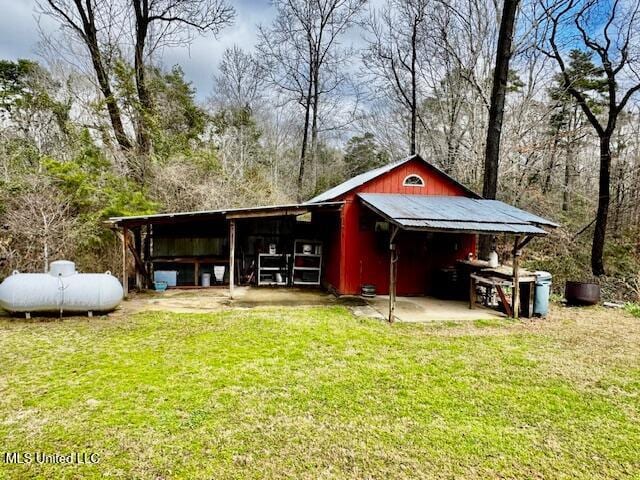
106,202 -> 344,228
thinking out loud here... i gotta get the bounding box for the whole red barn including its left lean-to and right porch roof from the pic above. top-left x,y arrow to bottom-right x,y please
111,155 -> 556,316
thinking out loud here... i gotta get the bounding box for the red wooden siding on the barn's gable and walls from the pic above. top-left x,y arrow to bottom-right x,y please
325,159 -> 476,295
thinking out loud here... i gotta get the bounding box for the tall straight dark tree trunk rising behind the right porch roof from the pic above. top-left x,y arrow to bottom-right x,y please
480,0 -> 519,258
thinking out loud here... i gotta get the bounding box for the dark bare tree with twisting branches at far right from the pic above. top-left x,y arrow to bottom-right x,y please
540,0 -> 640,275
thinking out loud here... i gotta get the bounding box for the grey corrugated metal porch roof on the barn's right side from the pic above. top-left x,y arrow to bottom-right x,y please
358,193 -> 557,235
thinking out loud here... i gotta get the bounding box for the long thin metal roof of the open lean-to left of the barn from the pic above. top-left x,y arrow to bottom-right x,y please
108,202 -> 344,225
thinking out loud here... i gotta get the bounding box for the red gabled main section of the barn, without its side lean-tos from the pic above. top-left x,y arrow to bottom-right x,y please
308,155 -> 480,295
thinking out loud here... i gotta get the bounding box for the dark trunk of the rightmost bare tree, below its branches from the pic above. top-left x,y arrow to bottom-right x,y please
591,134 -> 611,276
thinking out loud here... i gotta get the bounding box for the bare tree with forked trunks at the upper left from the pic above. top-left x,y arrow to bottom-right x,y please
38,0 -> 235,183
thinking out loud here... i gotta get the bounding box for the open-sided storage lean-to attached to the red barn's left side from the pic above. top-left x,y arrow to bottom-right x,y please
108,202 -> 343,298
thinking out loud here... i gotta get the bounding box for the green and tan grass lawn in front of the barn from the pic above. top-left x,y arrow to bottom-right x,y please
0,307 -> 640,479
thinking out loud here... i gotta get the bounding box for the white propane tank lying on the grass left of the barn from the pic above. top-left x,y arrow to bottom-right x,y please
0,260 -> 124,313
